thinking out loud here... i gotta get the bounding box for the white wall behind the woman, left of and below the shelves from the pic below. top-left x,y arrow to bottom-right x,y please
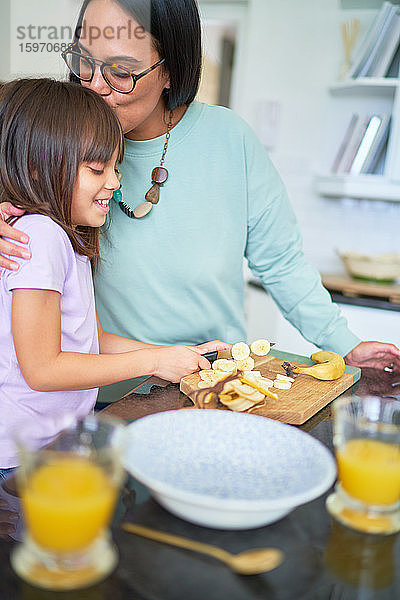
233,0 -> 400,272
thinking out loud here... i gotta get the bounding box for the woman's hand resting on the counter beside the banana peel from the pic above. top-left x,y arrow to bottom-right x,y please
344,342 -> 400,372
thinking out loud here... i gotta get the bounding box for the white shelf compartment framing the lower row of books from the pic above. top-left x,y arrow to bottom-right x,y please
314,77 -> 400,202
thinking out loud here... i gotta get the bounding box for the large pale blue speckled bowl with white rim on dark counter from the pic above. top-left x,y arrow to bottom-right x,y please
123,410 -> 336,529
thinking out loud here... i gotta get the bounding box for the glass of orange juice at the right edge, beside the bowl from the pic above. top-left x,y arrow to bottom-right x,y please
327,396 -> 400,534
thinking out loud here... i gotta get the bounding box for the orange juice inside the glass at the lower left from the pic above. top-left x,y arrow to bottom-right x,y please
21,455 -> 117,552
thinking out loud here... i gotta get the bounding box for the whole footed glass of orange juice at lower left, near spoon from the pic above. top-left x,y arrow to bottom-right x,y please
11,415 -> 124,590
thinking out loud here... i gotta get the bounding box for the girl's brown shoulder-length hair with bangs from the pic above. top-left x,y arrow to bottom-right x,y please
0,79 -> 123,268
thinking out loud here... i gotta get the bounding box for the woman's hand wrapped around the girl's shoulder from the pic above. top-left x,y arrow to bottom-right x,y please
0,202 -> 31,271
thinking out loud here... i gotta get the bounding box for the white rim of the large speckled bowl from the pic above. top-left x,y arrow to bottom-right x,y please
122,409 -> 336,512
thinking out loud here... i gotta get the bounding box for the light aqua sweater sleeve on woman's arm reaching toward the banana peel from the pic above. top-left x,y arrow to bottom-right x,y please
244,124 -> 360,356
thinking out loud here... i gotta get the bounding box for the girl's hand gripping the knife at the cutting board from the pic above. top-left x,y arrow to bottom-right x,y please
151,346 -> 216,383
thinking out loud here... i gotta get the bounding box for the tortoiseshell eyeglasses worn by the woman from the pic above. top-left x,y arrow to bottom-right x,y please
61,42 -> 165,94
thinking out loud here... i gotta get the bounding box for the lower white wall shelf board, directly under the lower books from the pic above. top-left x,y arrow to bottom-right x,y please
314,174 -> 400,202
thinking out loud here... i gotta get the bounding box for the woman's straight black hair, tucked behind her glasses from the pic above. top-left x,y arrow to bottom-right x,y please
70,0 -> 201,110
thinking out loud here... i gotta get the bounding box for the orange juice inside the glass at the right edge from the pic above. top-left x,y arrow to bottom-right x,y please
337,439 -> 400,506
